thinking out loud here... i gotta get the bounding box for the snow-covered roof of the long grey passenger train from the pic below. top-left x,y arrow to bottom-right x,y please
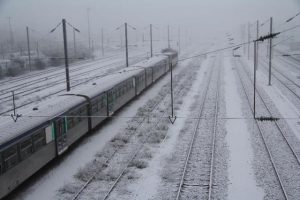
0,56 -> 163,147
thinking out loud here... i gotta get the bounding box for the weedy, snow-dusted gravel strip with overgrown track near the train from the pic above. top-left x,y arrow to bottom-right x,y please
55,49 -> 206,199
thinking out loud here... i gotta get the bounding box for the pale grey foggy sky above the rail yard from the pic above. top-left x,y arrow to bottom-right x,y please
0,0 -> 300,44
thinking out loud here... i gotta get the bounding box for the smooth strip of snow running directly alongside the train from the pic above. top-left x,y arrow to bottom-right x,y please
16,49 -> 186,200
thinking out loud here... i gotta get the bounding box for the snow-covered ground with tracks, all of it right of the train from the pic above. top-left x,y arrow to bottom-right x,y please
4,41 -> 300,200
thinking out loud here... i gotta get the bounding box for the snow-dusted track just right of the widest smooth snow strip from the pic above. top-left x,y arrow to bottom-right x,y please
235,57 -> 300,200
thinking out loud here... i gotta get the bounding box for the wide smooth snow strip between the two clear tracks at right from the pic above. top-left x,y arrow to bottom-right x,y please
224,58 -> 264,200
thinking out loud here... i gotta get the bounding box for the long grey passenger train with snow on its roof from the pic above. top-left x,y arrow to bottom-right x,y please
0,49 -> 178,198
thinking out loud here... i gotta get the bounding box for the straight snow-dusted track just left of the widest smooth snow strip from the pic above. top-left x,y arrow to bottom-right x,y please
176,56 -> 221,200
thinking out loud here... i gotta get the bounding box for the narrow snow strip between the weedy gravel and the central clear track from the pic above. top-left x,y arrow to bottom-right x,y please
128,55 -> 205,199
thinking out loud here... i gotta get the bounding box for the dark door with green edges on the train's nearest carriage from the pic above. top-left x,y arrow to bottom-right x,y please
55,118 -> 68,155
